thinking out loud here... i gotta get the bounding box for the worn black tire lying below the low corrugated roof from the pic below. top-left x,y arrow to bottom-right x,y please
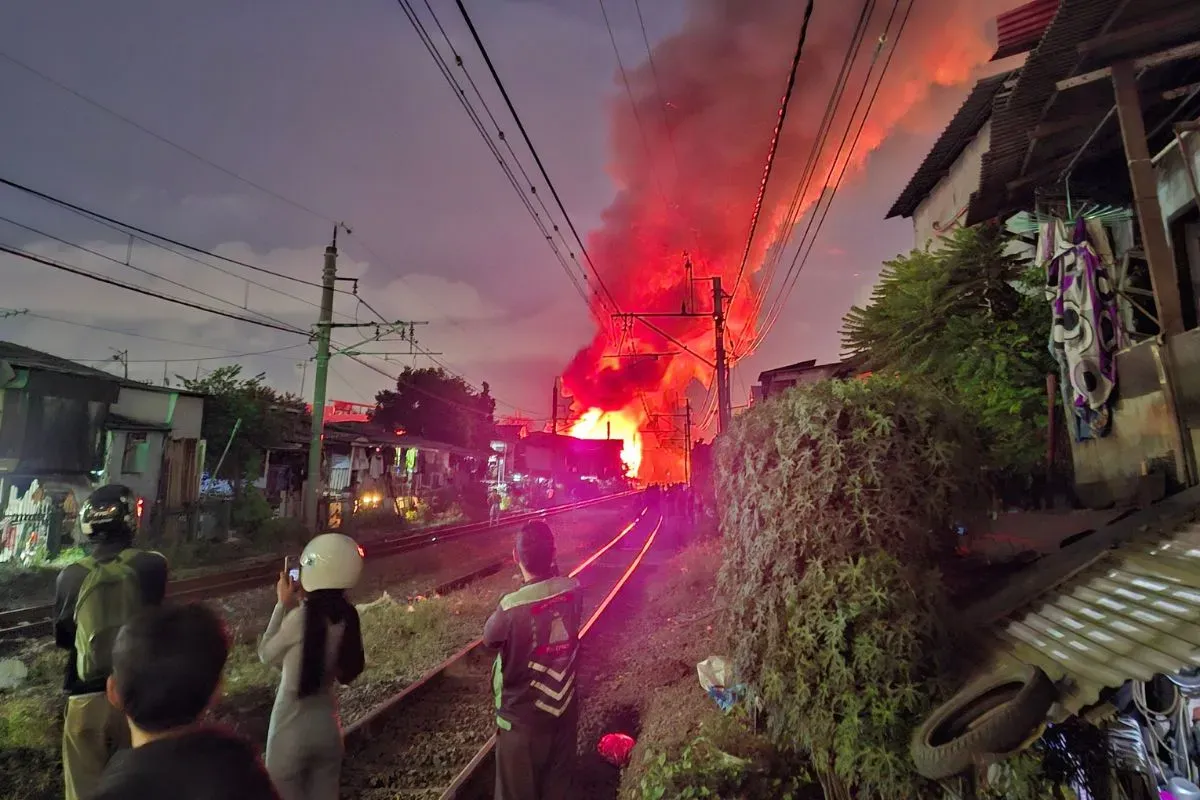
910,666 -> 1057,781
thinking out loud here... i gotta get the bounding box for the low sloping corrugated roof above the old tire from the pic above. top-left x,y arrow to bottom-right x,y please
966,489 -> 1200,718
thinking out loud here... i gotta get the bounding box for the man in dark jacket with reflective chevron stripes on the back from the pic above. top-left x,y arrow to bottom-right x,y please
484,521 -> 583,800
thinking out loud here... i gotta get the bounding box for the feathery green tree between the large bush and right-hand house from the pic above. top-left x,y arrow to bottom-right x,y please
842,225 -> 1055,476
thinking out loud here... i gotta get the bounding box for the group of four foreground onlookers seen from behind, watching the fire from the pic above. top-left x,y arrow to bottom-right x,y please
55,486 -> 582,800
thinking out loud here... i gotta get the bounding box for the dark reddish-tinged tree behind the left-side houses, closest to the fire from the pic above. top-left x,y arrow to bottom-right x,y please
372,367 -> 496,450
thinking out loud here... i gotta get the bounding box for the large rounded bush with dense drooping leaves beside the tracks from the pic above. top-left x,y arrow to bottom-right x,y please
715,378 -> 979,800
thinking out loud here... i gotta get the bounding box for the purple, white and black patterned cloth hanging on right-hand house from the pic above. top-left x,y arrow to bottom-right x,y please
1038,219 -> 1121,440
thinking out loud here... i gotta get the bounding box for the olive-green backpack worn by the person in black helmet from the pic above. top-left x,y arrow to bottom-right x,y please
74,549 -> 143,681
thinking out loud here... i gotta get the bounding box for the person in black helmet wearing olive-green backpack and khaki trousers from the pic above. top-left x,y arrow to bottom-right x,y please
54,485 -> 167,800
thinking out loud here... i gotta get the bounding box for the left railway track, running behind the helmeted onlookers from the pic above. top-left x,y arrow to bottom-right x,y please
0,492 -> 636,639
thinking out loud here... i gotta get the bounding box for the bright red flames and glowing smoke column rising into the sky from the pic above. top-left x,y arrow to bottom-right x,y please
563,0 -> 1015,480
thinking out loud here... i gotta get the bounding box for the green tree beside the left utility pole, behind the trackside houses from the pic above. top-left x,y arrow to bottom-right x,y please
180,365 -> 311,493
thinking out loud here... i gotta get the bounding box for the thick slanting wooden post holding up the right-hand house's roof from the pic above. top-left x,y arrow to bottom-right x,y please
1110,61 -> 1183,336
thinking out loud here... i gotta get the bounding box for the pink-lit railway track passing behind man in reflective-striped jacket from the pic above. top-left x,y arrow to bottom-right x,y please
342,510 -> 662,800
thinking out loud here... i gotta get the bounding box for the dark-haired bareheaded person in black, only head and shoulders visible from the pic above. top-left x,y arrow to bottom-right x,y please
91,604 -> 278,800
